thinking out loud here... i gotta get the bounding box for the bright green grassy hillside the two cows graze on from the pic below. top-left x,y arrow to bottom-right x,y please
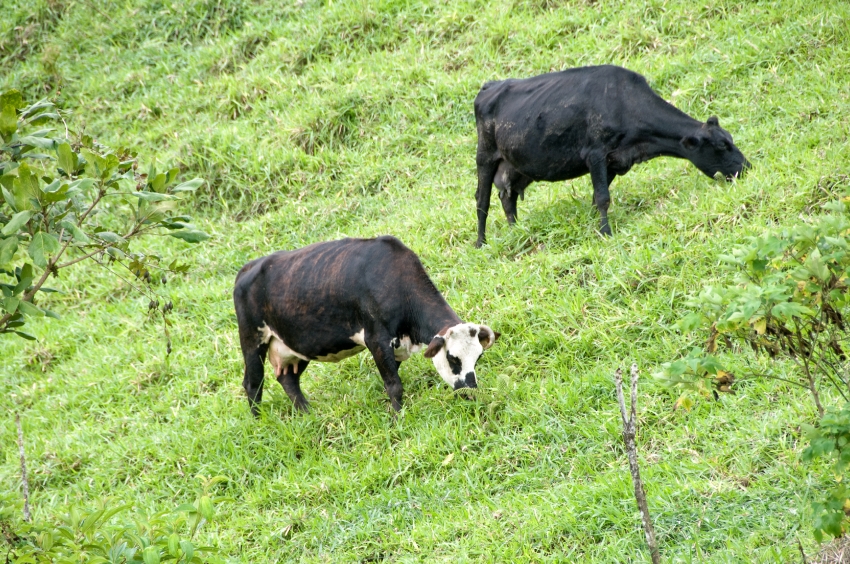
0,0 -> 850,563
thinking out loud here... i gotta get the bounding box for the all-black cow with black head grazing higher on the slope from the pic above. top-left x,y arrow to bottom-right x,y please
475,65 -> 750,247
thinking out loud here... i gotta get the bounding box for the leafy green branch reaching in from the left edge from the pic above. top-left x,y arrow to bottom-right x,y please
0,90 -> 209,348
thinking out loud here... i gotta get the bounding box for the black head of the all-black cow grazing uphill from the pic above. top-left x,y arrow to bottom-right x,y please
681,116 -> 750,180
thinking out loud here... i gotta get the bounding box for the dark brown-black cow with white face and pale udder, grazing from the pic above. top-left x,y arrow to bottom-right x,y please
233,236 -> 499,415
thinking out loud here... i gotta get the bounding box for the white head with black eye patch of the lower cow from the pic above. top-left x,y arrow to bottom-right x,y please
425,323 -> 499,390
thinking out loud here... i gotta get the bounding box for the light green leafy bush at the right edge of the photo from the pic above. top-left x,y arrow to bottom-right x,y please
657,187 -> 850,540
